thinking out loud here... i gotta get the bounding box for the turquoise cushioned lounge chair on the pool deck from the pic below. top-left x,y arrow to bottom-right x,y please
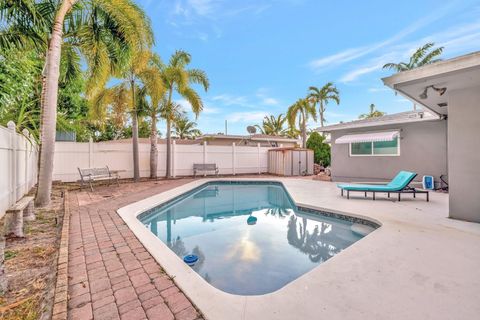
337,171 -> 429,201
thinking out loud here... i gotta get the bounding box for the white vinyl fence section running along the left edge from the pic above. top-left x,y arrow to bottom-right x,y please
0,122 -> 38,217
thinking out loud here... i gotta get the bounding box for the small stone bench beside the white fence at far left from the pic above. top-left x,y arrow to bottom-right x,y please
4,197 -> 35,238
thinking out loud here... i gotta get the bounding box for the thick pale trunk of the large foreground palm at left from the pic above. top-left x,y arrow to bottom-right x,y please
35,0 -> 76,207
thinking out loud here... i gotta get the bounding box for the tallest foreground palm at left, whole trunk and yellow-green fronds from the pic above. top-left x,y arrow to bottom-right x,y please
0,0 -> 153,206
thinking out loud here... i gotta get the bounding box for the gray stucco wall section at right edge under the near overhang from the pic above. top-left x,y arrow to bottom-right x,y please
448,86 -> 480,222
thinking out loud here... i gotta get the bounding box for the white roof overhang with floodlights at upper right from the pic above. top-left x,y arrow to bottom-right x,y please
382,52 -> 480,115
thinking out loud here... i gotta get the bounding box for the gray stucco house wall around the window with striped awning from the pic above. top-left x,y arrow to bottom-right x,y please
331,120 -> 447,182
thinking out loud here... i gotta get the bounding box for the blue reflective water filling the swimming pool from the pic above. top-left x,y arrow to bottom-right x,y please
139,182 -> 368,295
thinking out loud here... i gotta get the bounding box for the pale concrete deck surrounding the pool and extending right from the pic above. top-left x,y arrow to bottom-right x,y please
118,177 -> 480,320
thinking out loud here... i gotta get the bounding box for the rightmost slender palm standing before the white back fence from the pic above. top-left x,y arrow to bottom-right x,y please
161,50 -> 209,178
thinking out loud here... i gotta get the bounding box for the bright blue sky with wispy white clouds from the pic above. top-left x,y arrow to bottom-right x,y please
138,0 -> 480,134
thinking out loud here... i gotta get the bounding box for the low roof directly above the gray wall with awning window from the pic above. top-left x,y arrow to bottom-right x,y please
315,110 -> 440,132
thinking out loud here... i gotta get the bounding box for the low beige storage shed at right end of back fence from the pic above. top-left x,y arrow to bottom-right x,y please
268,148 -> 313,176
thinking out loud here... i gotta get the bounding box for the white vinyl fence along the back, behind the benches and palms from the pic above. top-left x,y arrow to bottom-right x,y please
53,141 -> 271,182
